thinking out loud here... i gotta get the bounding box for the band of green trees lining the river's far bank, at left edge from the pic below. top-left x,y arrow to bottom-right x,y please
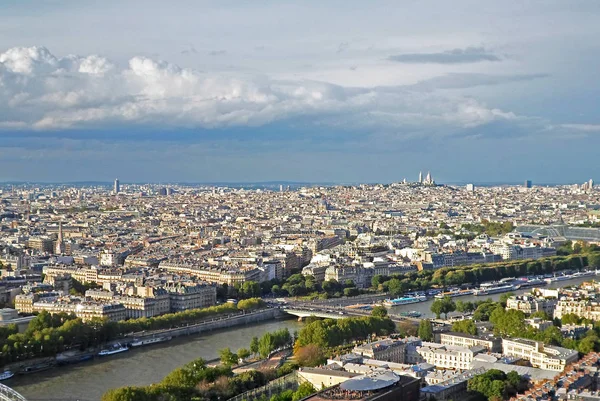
0,298 -> 264,365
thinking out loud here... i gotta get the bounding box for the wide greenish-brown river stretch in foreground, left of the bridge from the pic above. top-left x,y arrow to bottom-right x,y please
10,319 -> 302,401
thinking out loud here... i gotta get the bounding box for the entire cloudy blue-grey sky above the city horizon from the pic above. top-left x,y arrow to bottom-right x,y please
0,0 -> 600,183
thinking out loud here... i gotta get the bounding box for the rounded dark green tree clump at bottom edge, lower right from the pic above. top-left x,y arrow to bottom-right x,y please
467,369 -> 529,401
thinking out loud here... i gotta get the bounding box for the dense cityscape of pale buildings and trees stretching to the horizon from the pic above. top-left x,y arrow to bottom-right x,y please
0,178 -> 600,401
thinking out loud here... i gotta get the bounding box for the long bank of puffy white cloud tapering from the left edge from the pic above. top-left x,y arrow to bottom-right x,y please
0,47 -> 518,134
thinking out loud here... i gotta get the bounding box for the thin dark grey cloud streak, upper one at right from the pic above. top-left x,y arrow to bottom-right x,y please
388,47 -> 501,64
